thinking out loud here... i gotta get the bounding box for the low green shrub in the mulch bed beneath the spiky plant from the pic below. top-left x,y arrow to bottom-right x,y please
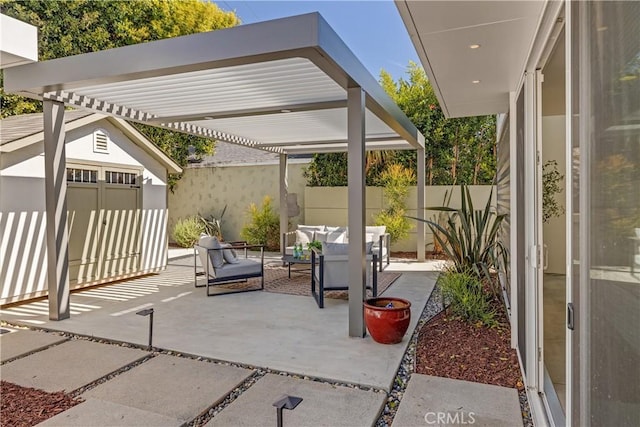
438,270 -> 496,326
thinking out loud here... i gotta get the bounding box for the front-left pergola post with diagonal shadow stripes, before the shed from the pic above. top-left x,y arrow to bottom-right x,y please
43,99 -> 70,320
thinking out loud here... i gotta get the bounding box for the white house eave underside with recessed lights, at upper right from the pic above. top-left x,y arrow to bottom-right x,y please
395,0 -> 549,117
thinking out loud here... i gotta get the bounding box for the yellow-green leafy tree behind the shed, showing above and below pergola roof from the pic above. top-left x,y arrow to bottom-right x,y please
0,0 -> 240,182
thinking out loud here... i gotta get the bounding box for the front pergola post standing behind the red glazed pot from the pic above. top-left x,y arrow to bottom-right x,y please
347,87 -> 367,338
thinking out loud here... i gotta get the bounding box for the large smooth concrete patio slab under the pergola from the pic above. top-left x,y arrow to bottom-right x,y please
0,250 -> 438,390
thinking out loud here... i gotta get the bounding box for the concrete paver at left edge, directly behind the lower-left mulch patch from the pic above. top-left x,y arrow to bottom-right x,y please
2,340 -> 147,392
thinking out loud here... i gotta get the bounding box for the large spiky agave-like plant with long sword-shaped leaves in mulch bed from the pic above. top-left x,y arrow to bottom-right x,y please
413,185 -> 508,294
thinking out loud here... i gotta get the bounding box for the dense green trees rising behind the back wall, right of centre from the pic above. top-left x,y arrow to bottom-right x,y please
305,62 -> 496,186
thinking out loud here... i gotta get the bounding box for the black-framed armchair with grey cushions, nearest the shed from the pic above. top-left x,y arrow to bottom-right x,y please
193,236 -> 264,296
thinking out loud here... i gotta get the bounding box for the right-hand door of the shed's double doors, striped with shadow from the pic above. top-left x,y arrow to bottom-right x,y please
102,168 -> 140,277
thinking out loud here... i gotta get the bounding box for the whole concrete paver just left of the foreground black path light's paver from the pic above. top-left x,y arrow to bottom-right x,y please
81,355 -> 253,422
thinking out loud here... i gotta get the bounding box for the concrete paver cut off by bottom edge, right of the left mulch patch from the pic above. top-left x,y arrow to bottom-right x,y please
38,399 -> 183,427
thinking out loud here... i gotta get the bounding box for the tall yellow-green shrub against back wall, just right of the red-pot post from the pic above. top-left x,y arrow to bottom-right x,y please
373,164 -> 416,242
